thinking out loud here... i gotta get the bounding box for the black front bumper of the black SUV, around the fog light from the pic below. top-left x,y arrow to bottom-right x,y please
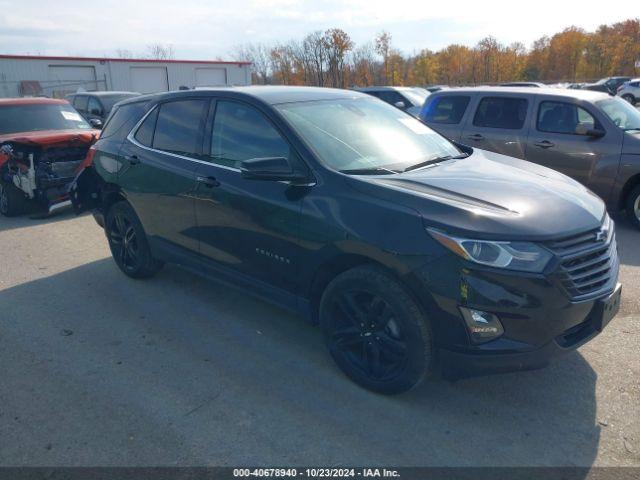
414,248 -> 621,379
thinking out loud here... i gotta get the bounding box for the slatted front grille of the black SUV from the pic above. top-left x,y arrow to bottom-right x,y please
546,216 -> 618,299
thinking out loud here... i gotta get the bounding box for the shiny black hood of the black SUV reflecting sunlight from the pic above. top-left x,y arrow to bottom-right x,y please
349,149 -> 605,240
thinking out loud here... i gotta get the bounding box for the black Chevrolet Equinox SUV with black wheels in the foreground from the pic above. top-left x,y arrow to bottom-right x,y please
72,87 -> 620,393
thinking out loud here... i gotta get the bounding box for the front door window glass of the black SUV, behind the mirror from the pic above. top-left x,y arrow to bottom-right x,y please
211,100 -> 290,168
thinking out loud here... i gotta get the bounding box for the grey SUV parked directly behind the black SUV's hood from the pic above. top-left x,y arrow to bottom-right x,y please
420,87 -> 640,228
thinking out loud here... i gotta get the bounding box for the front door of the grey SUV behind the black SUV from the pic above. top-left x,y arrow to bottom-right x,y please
526,95 -> 622,199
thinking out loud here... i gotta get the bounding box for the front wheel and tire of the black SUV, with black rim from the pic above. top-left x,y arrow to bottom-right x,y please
320,265 -> 433,394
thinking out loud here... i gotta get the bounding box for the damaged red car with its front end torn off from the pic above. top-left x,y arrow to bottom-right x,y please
0,98 -> 99,216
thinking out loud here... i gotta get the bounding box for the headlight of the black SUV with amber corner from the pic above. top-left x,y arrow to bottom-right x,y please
427,228 -> 553,272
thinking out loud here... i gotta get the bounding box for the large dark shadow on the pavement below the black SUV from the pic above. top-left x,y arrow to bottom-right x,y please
0,259 -> 600,466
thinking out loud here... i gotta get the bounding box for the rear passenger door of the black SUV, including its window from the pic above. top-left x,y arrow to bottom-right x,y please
118,98 -> 209,251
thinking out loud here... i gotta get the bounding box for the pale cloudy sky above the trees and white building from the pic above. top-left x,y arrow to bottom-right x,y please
0,0 -> 633,59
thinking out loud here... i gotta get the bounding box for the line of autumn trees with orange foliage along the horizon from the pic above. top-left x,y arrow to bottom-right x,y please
234,18 -> 640,88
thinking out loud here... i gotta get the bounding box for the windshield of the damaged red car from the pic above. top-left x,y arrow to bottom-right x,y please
0,103 -> 91,135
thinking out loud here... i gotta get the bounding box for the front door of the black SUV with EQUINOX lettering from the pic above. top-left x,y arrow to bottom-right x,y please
196,99 -> 304,293
